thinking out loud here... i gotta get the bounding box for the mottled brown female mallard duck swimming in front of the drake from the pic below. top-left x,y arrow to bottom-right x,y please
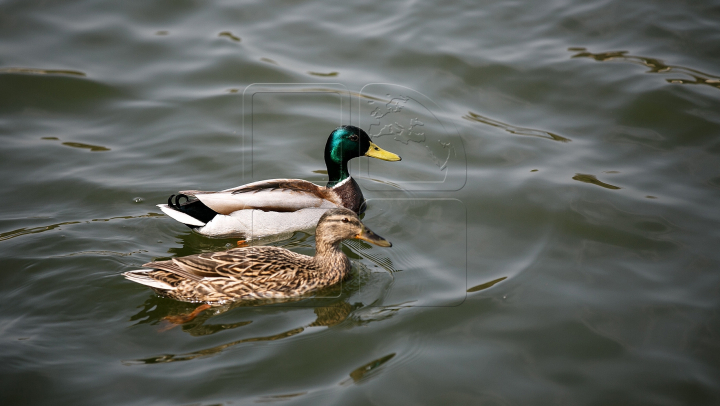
123,208 -> 392,304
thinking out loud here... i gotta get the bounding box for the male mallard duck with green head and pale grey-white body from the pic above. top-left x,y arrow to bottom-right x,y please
158,125 -> 401,240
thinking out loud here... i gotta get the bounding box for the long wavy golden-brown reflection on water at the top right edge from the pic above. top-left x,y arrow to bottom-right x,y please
568,48 -> 720,89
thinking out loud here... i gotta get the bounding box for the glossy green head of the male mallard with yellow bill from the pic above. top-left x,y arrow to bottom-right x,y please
325,125 -> 402,186
